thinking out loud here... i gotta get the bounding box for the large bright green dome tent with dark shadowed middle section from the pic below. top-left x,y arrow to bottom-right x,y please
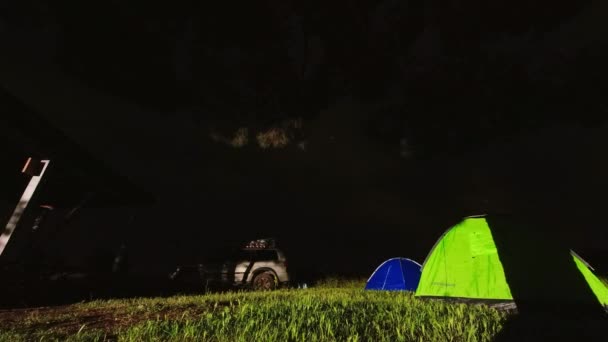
416,216 -> 608,307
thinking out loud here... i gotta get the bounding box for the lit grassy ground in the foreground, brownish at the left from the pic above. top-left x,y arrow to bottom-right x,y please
0,280 -> 506,342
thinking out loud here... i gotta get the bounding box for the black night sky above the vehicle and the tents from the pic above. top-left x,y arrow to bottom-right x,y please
0,0 -> 608,282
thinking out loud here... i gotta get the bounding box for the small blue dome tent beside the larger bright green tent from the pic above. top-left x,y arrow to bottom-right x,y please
365,258 -> 422,291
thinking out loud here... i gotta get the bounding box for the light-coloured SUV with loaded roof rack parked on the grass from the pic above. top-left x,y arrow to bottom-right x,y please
169,239 -> 289,290
